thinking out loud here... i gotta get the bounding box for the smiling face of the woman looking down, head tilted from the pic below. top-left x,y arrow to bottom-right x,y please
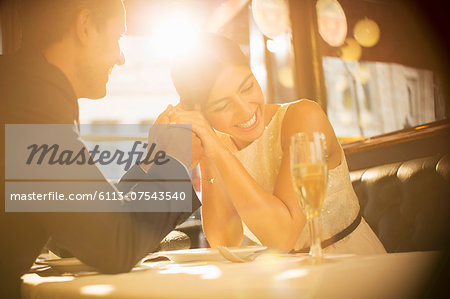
203,66 -> 264,148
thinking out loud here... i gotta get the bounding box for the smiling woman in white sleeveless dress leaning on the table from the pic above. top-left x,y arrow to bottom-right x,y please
162,34 -> 385,254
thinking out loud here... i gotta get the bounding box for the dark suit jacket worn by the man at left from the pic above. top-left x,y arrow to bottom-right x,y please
0,49 -> 200,298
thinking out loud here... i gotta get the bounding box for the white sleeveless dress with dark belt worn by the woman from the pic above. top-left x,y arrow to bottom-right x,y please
221,104 -> 386,254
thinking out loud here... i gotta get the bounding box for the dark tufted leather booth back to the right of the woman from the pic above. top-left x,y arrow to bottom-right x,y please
350,153 -> 450,252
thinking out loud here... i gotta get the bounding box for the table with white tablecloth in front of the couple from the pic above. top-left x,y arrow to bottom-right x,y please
22,252 -> 440,299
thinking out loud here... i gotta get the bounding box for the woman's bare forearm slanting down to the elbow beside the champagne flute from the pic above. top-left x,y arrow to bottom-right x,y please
205,145 -> 305,251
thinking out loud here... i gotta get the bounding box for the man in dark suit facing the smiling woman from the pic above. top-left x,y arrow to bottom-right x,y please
0,0 -> 200,298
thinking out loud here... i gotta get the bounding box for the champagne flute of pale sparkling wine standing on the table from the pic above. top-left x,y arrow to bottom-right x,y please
290,132 -> 328,263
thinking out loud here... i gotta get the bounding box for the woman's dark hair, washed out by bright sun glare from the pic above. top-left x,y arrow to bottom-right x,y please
171,33 -> 249,109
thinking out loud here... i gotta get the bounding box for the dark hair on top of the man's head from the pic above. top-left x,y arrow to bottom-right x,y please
19,0 -> 122,49
